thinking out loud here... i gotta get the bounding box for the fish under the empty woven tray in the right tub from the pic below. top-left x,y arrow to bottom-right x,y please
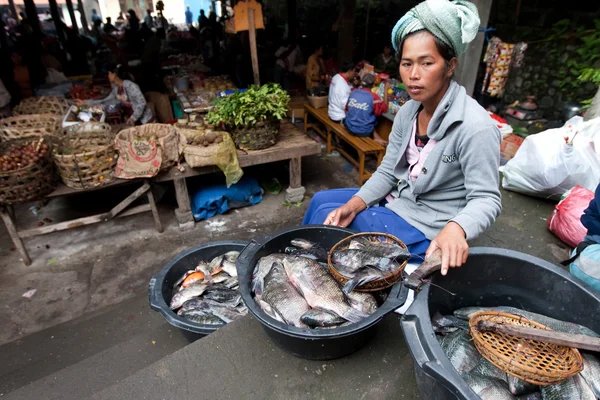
431,307 -> 600,400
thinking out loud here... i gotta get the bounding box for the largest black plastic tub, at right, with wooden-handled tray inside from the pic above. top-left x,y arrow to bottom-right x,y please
401,247 -> 600,400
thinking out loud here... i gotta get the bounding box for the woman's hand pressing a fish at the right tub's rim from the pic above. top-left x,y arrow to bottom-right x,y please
425,221 -> 469,275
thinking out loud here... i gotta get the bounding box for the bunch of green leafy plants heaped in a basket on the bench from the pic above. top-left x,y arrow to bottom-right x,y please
207,83 -> 290,128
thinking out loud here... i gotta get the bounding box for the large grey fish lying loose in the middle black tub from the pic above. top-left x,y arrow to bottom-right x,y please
252,239 -> 384,329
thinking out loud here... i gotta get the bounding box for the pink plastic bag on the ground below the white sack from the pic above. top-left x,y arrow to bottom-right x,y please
548,185 -> 594,247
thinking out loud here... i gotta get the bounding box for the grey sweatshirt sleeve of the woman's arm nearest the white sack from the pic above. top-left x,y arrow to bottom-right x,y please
451,127 -> 502,240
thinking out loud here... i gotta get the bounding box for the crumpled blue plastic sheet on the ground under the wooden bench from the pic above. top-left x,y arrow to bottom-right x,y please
192,177 -> 263,221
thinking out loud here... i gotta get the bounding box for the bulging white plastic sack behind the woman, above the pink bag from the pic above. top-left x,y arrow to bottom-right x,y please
502,117 -> 600,200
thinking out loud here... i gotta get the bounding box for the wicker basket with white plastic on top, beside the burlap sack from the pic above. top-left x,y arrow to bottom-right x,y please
52,122 -> 117,189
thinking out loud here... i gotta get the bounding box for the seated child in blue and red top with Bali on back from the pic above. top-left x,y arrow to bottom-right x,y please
344,74 -> 388,146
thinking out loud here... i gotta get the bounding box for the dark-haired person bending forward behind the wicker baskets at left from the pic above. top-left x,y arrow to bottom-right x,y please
75,64 -> 154,126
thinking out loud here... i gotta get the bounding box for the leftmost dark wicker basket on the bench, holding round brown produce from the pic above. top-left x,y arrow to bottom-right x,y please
0,137 -> 57,205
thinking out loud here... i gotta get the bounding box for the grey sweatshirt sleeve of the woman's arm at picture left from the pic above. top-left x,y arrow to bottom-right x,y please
356,116 -> 402,207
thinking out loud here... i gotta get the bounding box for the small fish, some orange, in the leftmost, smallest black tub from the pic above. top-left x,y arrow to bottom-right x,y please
169,251 -> 248,325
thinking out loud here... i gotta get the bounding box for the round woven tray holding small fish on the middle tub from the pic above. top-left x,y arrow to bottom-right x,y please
327,232 -> 408,292
